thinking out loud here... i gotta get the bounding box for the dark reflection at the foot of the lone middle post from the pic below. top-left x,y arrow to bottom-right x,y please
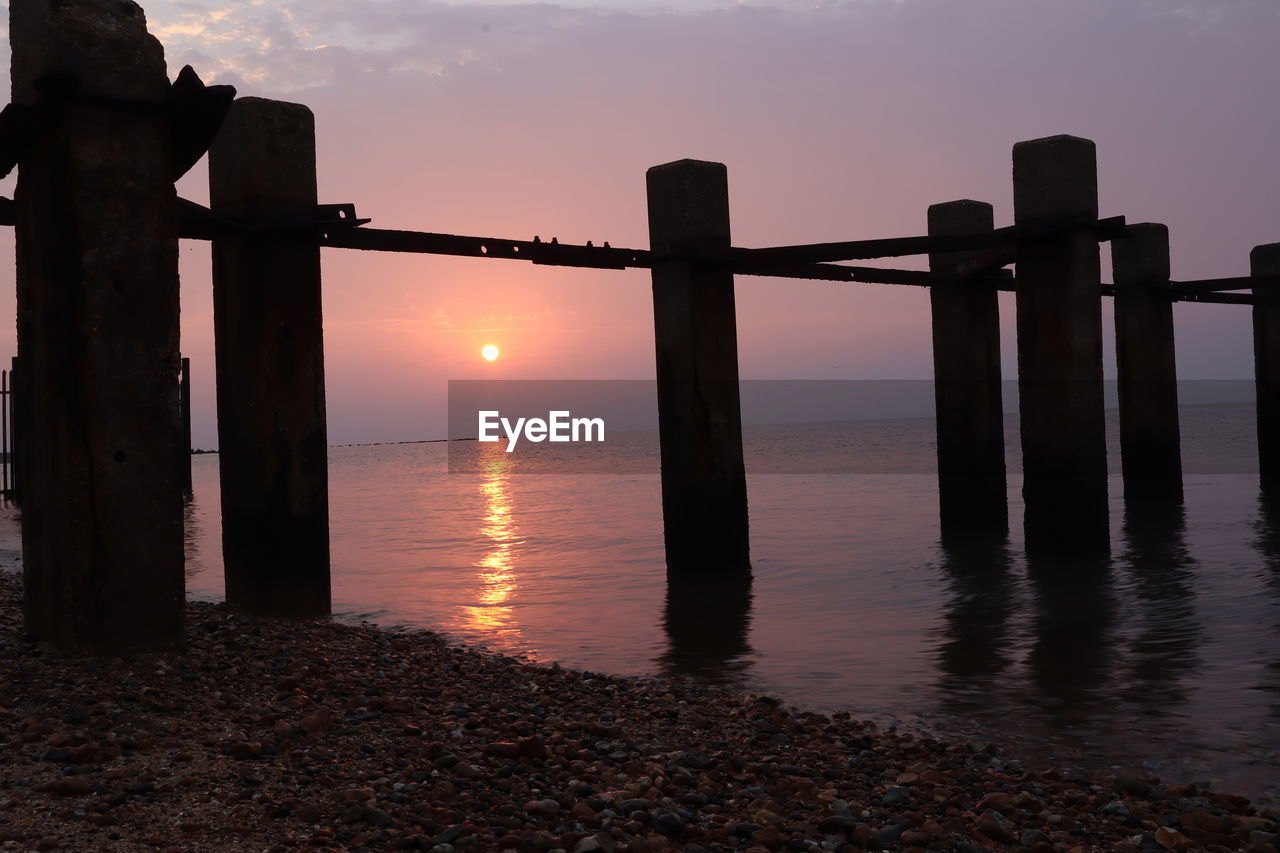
658,571 -> 751,683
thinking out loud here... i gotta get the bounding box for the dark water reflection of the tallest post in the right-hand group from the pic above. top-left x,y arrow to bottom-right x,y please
1027,551 -> 1116,724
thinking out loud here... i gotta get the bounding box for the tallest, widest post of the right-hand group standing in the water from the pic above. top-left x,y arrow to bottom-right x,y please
1014,136 -> 1108,552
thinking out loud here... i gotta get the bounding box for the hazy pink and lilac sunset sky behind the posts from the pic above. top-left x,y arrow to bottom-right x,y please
0,0 -> 1280,447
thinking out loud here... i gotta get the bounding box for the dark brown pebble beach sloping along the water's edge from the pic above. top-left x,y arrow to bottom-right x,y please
0,563 -> 1280,853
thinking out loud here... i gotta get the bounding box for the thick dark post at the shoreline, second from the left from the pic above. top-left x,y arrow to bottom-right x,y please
209,97 -> 330,617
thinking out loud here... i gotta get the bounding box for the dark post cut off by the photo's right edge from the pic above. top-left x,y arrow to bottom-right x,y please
1249,243 -> 1280,493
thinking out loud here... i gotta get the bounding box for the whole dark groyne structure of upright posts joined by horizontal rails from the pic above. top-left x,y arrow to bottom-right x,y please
0,0 -> 1280,653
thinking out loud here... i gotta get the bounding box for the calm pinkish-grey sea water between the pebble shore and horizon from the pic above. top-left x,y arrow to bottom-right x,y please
167,406 -> 1280,798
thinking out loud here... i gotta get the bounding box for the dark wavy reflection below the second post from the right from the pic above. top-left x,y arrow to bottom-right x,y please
1121,493 -> 1203,715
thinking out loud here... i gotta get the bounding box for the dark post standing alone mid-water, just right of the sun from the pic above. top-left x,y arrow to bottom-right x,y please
646,160 -> 750,574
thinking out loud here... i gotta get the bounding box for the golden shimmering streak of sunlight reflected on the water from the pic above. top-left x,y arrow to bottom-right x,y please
465,444 -> 521,634
